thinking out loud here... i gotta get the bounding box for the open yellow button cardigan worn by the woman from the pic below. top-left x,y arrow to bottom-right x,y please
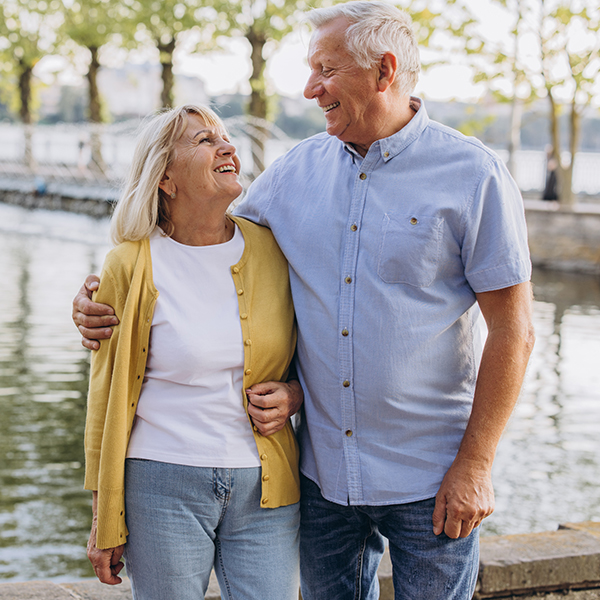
85,216 -> 300,548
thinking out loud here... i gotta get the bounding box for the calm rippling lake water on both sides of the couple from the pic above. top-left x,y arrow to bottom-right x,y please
0,204 -> 600,581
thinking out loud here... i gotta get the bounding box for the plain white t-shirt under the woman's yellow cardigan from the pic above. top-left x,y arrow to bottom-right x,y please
127,226 -> 260,468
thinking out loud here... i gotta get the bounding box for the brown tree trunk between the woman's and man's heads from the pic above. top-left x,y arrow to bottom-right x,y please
246,26 -> 269,178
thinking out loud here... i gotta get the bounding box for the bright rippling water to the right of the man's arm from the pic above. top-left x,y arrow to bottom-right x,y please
483,271 -> 600,534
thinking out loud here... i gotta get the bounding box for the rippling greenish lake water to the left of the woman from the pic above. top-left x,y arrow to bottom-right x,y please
0,206 -> 106,580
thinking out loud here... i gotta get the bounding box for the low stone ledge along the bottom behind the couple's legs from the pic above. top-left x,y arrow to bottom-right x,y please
0,521 -> 600,600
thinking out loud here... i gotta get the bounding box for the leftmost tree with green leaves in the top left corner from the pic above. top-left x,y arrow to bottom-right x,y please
0,0 -> 63,168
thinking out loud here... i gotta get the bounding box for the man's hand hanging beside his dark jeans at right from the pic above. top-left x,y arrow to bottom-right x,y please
433,457 -> 494,539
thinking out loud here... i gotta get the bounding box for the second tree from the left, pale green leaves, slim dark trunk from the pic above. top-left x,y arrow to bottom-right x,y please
64,0 -> 132,173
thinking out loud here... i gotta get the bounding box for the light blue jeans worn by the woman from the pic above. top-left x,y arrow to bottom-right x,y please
125,459 -> 299,600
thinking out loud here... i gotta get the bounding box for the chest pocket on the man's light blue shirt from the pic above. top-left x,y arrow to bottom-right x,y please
377,213 -> 444,287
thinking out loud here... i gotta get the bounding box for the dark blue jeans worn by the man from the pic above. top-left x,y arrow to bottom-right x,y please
300,476 -> 479,600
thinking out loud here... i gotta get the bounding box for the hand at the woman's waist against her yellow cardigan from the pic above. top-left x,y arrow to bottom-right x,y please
246,381 -> 304,435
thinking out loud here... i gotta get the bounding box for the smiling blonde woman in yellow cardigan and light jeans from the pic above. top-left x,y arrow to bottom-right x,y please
85,106 -> 299,600
